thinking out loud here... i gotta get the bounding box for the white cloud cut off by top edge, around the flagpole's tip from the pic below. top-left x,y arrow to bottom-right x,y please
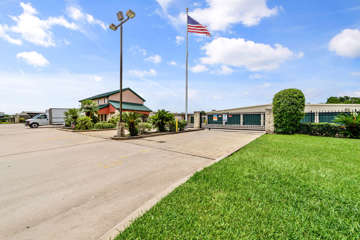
157,0 -> 278,31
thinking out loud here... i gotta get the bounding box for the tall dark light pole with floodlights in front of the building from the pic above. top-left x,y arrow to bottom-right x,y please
109,9 -> 135,137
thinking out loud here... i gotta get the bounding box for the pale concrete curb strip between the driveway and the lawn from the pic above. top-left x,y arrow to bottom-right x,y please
98,134 -> 264,240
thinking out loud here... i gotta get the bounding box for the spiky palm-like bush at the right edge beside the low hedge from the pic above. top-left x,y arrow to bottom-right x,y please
334,113 -> 360,138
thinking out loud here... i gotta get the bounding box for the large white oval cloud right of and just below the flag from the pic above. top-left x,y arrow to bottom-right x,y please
201,37 -> 297,71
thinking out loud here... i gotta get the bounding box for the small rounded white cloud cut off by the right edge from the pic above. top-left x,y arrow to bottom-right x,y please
329,29 -> 360,58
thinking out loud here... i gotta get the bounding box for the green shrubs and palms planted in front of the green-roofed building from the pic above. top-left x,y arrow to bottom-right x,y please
65,100 -> 187,136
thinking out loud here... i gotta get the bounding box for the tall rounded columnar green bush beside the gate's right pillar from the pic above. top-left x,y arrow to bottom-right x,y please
273,89 -> 305,134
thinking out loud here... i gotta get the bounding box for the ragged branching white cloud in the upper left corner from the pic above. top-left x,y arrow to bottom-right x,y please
0,2 -> 78,47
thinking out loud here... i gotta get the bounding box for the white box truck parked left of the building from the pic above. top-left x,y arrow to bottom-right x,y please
25,108 -> 69,128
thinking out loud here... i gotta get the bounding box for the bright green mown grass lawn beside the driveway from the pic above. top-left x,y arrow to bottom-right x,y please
117,135 -> 360,240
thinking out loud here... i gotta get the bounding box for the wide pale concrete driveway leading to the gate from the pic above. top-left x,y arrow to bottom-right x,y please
0,125 -> 263,240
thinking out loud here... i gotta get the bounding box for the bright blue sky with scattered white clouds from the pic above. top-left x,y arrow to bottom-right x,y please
0,0 -> 360,114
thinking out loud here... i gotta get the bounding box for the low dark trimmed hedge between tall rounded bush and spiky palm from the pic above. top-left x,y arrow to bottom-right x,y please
298,123 -> 344,137
